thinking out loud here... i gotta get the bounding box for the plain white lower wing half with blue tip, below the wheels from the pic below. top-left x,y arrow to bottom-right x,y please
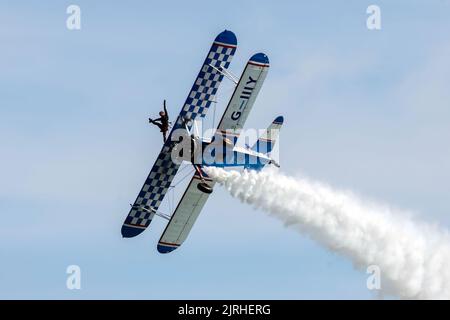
158,174 -> 214,253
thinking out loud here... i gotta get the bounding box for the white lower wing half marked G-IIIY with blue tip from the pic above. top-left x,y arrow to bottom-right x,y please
217,53 -> 269,133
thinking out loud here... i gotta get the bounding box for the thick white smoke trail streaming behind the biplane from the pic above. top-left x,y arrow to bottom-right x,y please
206,168 -> 450,299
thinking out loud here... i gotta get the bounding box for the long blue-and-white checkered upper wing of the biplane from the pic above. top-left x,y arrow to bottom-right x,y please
122,30 -> 237,238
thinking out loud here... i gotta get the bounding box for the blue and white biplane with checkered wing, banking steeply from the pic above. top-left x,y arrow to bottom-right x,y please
121,30 -> 283,253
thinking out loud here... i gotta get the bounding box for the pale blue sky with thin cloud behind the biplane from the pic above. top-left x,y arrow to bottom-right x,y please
0,0 -> 450,299
